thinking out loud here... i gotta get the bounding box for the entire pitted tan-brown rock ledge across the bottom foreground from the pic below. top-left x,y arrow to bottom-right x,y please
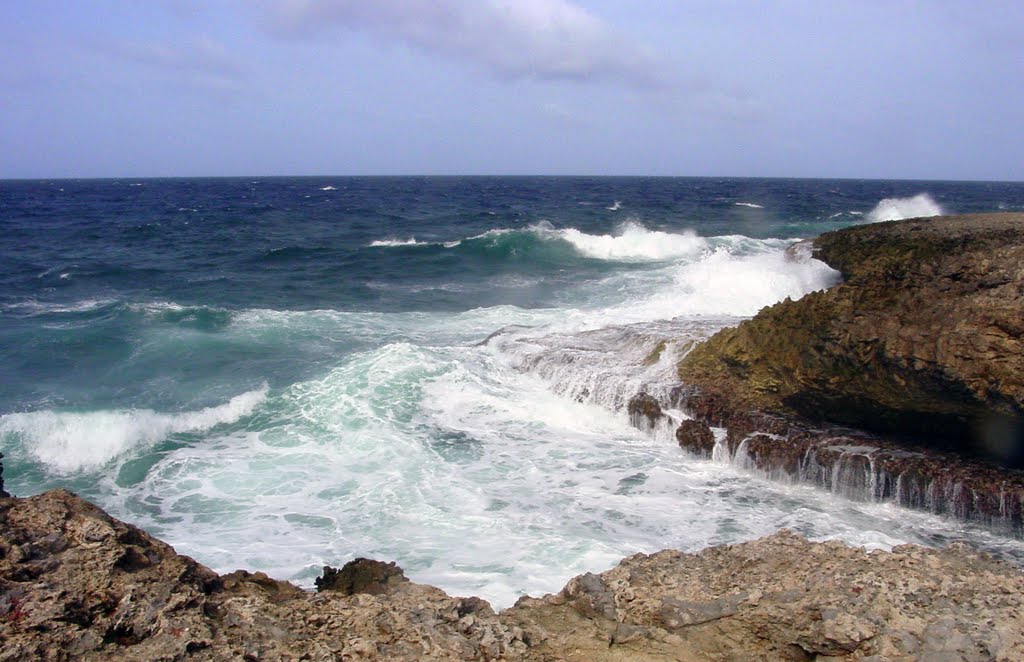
0,491 -> 1024,661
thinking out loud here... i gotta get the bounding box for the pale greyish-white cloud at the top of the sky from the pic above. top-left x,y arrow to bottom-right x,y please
263,0 -> 666,88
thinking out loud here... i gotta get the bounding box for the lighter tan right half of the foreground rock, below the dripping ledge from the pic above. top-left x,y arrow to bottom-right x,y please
502,531 -> 1024,661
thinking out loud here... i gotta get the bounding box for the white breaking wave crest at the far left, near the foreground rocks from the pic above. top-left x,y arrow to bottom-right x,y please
0,385 -> 267,473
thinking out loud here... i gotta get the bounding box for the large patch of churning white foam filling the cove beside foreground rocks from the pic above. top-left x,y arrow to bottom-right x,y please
77,336 -> 1024,607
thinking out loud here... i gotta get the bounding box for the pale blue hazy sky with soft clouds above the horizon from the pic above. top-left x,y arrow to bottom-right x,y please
0,0 -> 1024,180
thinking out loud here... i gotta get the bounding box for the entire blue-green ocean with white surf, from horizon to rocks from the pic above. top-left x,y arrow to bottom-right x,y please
0,176 -> 1024,607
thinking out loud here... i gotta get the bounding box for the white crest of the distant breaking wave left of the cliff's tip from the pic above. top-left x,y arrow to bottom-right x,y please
542,222 -> 708,260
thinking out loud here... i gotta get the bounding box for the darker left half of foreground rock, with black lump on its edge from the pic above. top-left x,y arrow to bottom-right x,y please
0,491 -> 527,661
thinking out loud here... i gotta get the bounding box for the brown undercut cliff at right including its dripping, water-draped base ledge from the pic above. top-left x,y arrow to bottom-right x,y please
647,213 -> 1024,535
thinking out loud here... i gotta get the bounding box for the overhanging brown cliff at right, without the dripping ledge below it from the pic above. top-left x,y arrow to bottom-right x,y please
679,213 -> 1024,464
